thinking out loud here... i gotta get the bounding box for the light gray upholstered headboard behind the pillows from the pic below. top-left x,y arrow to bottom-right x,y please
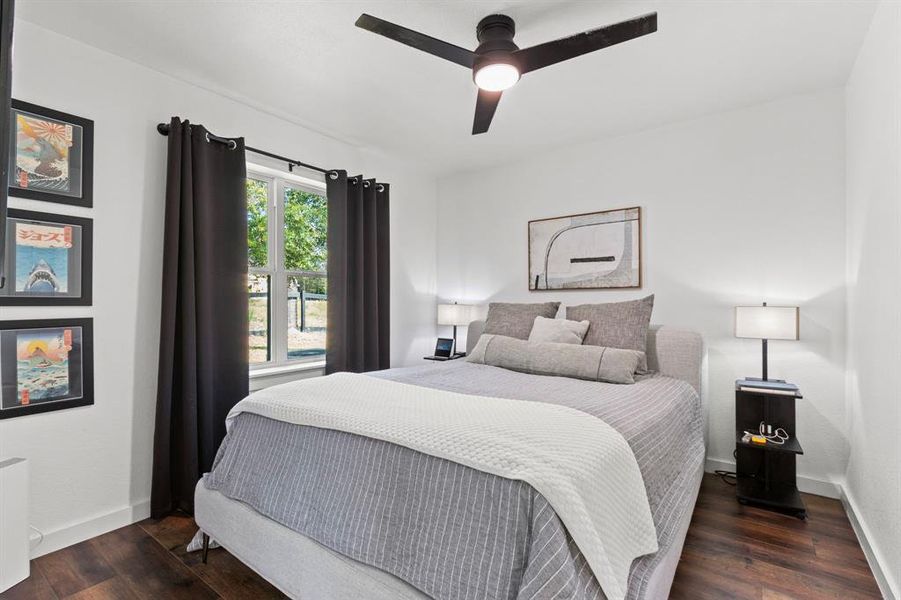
466,321 -> 704,394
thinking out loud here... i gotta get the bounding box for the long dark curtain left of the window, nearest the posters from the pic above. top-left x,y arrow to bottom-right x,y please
151,118 -> 248,517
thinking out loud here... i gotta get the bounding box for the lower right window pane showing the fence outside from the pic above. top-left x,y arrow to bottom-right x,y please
288,276 -> 328,360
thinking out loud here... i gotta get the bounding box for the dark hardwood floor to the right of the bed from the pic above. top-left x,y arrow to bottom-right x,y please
670,475 -> 882,600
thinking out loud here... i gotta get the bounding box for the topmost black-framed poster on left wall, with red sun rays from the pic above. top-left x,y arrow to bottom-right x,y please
9,99 -> 94,207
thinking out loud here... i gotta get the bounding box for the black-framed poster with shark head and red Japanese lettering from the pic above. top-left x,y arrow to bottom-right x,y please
0,208 -> 93,306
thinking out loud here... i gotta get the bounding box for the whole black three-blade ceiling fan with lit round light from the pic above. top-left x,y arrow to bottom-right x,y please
356,12 -> 657,135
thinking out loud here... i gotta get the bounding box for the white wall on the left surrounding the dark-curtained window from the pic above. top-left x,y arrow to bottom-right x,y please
0,21 -> 436,553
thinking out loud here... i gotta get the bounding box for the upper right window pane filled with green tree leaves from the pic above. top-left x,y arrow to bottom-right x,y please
285,187 -> 328,271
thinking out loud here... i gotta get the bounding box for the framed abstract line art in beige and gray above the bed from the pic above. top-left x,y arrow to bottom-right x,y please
529,206 -> 641,291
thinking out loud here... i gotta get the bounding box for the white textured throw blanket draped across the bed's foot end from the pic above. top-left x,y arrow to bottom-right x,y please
226,373 -> 657,600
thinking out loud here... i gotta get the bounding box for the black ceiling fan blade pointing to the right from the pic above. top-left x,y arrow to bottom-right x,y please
514,12 -> 657,73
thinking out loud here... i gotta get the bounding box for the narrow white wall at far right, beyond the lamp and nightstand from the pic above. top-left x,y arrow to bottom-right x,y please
845,1 -> 901,598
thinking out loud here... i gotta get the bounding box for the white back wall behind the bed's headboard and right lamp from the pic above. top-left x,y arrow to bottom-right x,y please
438,90 -> 848,494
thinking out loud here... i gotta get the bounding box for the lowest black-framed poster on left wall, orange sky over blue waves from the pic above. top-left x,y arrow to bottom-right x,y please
0,319 -> 94,419
